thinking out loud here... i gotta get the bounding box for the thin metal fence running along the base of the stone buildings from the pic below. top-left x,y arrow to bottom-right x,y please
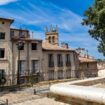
0,70 -> 96,87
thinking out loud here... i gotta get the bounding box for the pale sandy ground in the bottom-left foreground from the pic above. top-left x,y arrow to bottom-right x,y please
0,91 -> 68,105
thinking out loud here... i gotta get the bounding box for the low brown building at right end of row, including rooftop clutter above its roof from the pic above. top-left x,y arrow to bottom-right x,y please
76,48 -> 98,78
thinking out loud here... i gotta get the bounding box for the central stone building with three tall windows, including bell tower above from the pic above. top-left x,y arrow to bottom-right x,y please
42,27 -> 79,80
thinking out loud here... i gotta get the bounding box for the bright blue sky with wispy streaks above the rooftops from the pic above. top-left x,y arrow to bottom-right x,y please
0,0 -> 104,58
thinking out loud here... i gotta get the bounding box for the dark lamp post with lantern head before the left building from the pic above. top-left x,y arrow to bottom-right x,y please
16,38 -> 24,85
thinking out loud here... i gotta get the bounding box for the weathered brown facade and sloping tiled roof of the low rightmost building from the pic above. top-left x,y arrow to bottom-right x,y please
78,57 -> 98,78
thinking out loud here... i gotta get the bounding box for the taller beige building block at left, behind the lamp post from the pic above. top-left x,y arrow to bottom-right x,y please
0,18 -> 42,85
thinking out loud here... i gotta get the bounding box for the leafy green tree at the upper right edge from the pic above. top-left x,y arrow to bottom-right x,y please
82,0 -> 105,56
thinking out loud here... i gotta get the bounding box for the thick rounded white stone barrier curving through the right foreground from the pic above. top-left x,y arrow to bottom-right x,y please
50,77 -> 105,105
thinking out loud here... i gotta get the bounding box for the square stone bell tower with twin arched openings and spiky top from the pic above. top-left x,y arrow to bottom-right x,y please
45,26 -> 58,46
